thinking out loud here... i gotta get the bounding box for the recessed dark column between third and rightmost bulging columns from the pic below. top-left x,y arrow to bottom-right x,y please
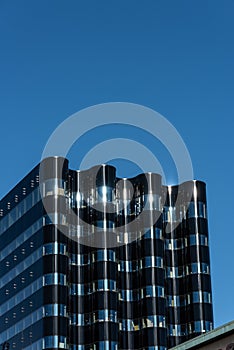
164,186 -> 187,348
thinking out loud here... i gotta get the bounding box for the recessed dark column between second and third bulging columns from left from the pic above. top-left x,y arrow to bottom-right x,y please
116,179 -> 140,349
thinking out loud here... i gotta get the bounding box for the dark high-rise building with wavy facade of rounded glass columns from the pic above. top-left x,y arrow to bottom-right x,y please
0,157 -> 213,350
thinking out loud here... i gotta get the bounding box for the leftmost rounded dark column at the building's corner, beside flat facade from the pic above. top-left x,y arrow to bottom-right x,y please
40,157 -> 69,348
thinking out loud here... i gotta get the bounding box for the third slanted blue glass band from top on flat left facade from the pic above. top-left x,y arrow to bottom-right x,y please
0,247 -> 42,288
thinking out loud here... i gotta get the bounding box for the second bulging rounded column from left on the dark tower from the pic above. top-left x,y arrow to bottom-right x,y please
91,165 -> 118,350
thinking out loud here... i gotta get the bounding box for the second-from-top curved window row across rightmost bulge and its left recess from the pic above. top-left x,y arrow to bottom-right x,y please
165,234 -> 208,250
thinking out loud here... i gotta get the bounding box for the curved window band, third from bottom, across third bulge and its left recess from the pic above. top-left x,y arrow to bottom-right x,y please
119,285 -> 165,301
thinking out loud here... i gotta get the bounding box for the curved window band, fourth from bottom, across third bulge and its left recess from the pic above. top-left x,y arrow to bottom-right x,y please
118,256 -> 163,272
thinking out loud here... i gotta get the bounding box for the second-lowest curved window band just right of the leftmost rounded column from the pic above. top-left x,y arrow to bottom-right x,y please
69,309 -> 118,326
